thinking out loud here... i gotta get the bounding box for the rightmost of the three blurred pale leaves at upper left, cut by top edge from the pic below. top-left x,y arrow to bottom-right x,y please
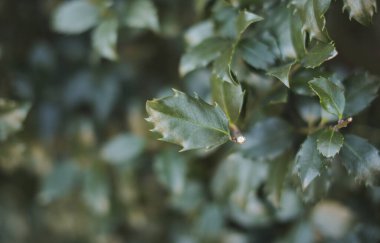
125,0 -> 159,31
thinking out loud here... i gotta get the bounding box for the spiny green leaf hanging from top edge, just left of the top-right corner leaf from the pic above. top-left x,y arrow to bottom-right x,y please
292,0 -> 331,42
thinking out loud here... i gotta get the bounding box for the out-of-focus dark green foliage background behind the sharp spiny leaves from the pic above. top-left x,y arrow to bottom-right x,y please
0,0 -> 380,243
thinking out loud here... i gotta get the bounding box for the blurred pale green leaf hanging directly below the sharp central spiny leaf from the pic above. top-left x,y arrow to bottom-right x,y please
154,150 -> 187,194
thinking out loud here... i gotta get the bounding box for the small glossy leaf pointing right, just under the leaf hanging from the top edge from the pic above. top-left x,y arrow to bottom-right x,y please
300,41 -> 338,68
